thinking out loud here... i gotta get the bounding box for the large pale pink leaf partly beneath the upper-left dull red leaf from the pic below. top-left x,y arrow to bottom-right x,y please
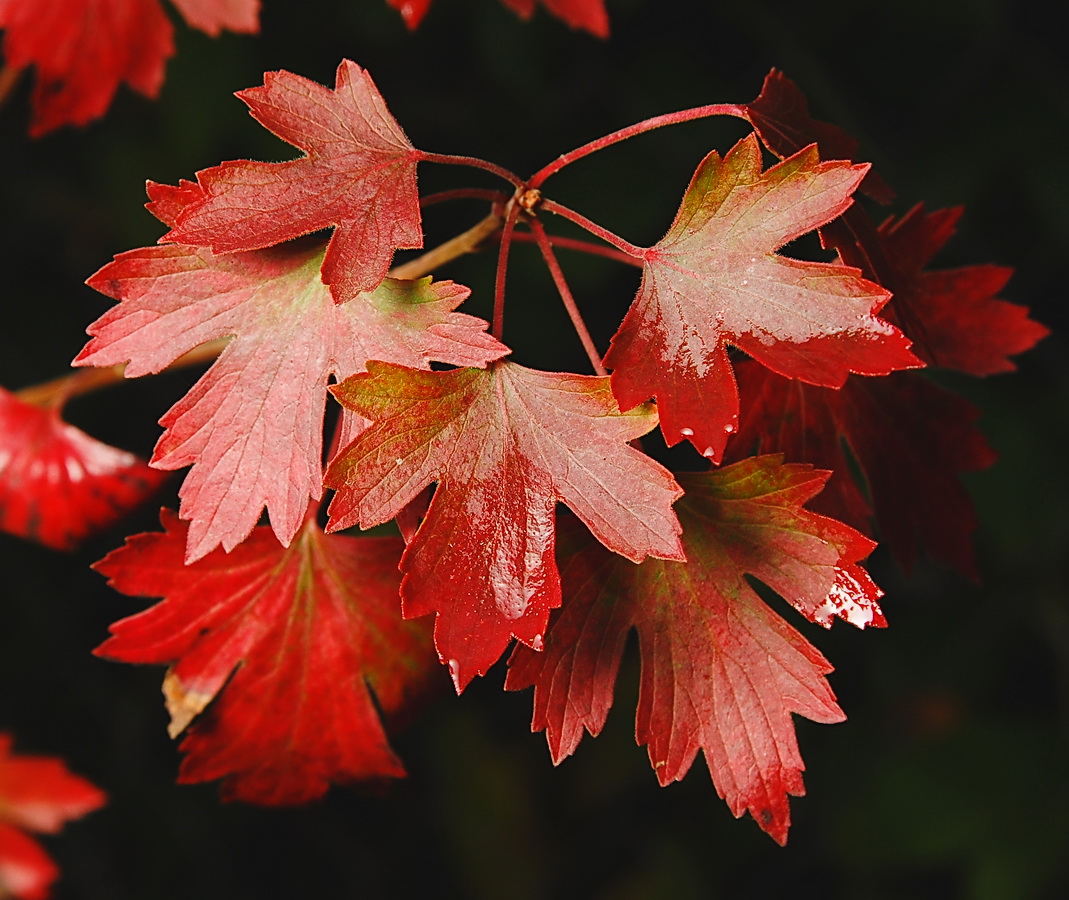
75,198 -> 508,561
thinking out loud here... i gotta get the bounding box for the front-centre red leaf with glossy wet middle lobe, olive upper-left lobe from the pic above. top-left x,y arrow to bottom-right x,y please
326,362 -> 682,690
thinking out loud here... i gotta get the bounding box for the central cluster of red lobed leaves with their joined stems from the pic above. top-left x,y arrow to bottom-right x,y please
2,61 -> 1044,842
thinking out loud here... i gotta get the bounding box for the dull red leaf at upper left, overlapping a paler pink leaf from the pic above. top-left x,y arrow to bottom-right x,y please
161,60 -> 423,302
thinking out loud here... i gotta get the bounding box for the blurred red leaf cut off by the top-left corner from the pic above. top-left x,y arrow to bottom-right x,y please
0,0 -> 259,136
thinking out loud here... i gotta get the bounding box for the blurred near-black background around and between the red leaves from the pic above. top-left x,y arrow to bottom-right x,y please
0,0 -> 1069,900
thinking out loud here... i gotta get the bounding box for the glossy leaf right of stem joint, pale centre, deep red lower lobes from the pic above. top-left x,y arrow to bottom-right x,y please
605,135 -> 920,462
